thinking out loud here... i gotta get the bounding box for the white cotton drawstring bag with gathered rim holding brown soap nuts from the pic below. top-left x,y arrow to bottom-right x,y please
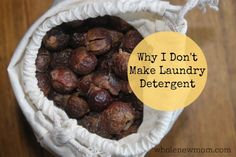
8,0 -> 218,157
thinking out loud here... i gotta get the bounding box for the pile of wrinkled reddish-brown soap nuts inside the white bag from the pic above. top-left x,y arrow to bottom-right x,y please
35,16 -> 143,140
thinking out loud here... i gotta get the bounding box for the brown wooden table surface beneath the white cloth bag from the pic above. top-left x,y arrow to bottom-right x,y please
0,0 -> 236,157
